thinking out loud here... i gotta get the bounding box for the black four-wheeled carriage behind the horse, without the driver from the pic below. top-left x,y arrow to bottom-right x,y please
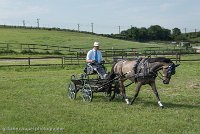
68,62 -> 117,102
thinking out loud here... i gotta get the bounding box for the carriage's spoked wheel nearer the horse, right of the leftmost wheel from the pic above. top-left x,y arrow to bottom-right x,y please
82,84 -> 93,102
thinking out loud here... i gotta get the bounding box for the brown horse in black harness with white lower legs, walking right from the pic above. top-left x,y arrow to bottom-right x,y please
108,57 -> 180,108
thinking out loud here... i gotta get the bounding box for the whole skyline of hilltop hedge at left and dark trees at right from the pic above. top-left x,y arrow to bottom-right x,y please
0,25 -> 200,43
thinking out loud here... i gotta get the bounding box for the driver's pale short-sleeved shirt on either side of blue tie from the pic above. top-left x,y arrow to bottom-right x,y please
86,49 -> 103,63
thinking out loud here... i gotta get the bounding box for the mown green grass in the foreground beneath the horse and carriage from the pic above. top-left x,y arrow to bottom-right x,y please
0,62 -> 200,134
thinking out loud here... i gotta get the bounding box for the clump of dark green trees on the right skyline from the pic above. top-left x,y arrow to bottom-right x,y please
110,25 -> 200,41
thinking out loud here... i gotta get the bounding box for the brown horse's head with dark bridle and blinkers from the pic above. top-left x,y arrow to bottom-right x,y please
163,62 -> 180,84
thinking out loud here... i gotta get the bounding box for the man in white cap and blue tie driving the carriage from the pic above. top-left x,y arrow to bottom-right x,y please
86,42 -> 107,79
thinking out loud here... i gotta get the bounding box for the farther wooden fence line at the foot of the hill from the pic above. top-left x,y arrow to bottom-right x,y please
0,43 -> 199,57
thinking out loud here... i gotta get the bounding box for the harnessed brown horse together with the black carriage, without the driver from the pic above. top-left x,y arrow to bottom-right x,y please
68,57 -> 180,108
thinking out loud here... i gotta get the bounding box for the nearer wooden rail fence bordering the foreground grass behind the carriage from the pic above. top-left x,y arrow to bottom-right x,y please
0,54 -> 200,67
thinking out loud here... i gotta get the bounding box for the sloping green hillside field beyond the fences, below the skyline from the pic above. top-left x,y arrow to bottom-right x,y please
0,28 -> 167,49
